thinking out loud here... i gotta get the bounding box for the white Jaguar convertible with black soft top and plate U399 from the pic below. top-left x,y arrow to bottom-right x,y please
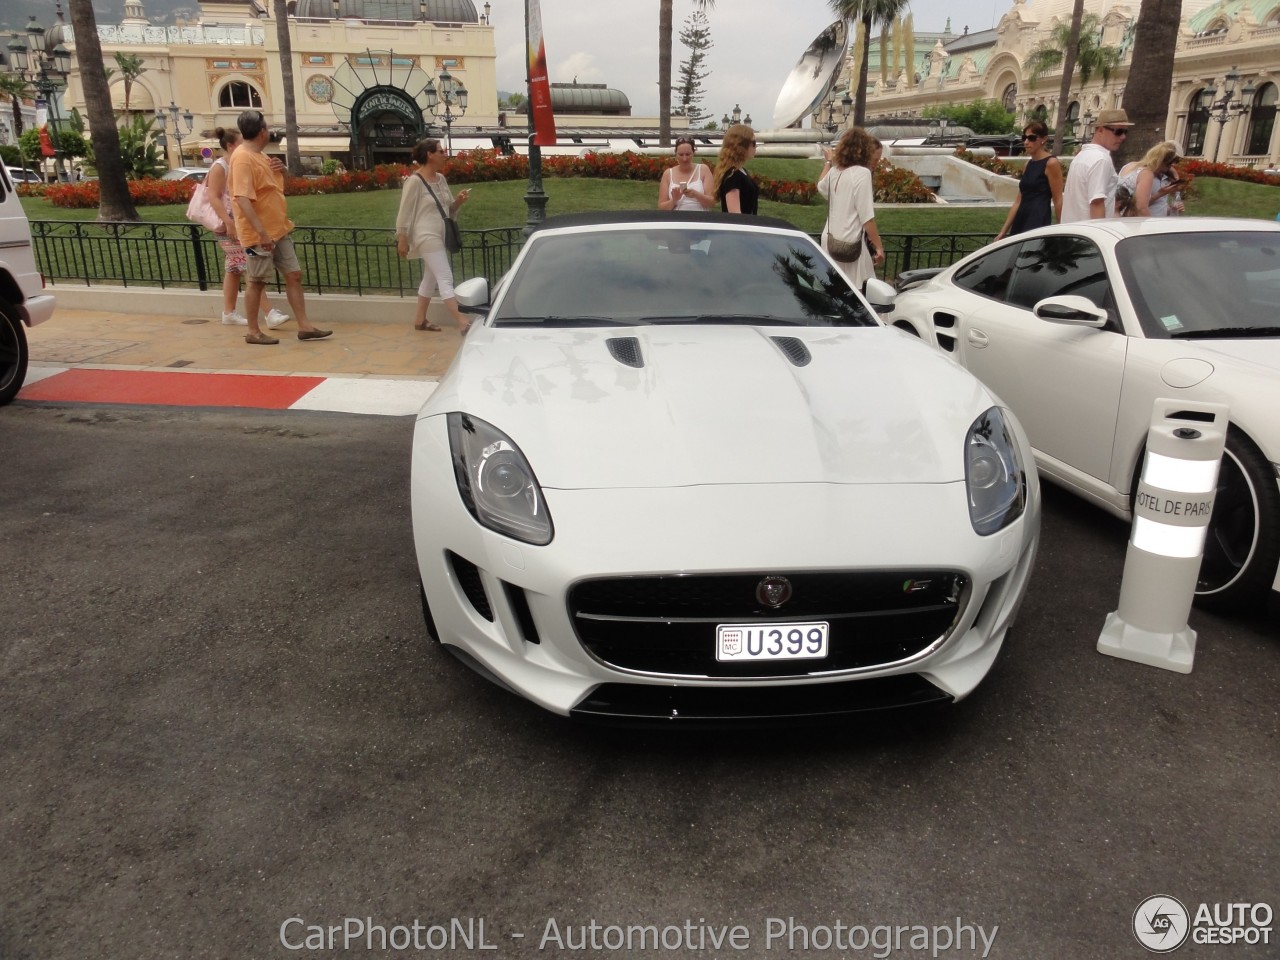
412,211 -> 1041,722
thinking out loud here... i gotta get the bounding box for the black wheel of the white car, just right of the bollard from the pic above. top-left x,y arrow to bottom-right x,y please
1196,428 -> 1280,609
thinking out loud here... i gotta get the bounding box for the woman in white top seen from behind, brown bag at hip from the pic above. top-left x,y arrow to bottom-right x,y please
818,127 -> 884,289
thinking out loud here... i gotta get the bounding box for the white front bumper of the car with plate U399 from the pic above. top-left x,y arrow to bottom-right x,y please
411,417 -> 1039,719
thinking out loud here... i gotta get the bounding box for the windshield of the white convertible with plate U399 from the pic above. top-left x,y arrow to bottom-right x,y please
494,224 -> 879,326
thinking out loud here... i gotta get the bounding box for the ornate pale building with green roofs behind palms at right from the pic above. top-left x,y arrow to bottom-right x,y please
845,0 -> 1280,168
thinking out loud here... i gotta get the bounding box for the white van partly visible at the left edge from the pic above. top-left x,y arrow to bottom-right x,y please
0,169 -> 54,406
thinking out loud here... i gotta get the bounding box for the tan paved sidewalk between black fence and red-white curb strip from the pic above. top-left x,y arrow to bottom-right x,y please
27,287 -> 462,380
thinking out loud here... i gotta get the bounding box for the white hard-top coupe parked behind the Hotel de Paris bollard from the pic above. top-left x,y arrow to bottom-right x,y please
892,218 -> 1280,608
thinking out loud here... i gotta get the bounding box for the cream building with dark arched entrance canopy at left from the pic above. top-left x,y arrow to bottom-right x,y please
50,0 -> 504,169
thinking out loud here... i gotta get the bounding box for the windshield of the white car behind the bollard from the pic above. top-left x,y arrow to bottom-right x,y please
1116,230 -> 1280,339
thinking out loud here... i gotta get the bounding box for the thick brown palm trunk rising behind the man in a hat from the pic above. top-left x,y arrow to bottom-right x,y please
1120,0 -> 1183,164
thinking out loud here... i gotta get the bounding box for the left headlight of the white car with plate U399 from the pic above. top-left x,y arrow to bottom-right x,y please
448,413 -> 552,545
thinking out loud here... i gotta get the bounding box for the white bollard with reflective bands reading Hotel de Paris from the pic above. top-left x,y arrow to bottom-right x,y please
1098,399 -> 1228,673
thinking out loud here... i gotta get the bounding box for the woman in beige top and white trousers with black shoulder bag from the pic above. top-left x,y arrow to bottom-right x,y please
396,138 -> 471,333
